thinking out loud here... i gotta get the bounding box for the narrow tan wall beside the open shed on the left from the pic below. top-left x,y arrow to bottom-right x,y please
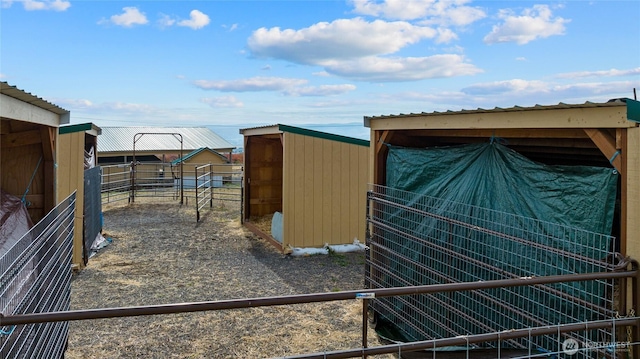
57,131 -> 85,268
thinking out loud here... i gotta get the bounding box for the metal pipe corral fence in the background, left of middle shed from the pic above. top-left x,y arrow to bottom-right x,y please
101,163 -> 243,220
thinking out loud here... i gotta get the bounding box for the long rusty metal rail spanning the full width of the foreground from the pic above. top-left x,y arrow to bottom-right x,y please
0,270 -> 639,327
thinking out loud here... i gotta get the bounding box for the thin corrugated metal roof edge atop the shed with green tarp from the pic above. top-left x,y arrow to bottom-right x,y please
364,98 -> 627,122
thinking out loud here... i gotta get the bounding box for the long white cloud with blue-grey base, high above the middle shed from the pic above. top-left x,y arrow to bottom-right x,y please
248,18 -> 439,65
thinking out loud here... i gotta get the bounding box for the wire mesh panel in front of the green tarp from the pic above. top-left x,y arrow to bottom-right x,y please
366,186 -> 616,358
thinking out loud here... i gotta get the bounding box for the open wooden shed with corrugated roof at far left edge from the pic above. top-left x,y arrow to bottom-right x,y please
0,82 -> 69,223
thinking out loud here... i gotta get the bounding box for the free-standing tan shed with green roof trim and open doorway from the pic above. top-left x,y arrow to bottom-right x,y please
240,124 -> 369,252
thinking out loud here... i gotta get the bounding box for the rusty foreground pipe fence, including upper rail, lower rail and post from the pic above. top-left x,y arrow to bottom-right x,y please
0,268 -> 640,359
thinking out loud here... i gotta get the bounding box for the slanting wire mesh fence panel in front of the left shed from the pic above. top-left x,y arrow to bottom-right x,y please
0,192 -> 76,358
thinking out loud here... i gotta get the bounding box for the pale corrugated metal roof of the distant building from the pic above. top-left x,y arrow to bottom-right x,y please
98,127 -> 235,155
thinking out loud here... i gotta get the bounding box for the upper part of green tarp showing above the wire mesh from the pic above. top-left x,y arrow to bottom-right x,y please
387,141 -> 618,235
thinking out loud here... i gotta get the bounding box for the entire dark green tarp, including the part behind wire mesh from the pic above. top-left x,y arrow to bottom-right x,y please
372,141 -> 618,347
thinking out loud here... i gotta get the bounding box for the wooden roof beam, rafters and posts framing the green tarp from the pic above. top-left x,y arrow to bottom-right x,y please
364,99 -> 640,259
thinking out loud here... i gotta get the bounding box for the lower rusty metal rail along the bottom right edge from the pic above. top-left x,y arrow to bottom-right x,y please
285,317 -> 640,359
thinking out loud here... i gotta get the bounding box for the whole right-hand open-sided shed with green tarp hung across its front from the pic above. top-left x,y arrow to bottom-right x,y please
364,99 -> 640,355
